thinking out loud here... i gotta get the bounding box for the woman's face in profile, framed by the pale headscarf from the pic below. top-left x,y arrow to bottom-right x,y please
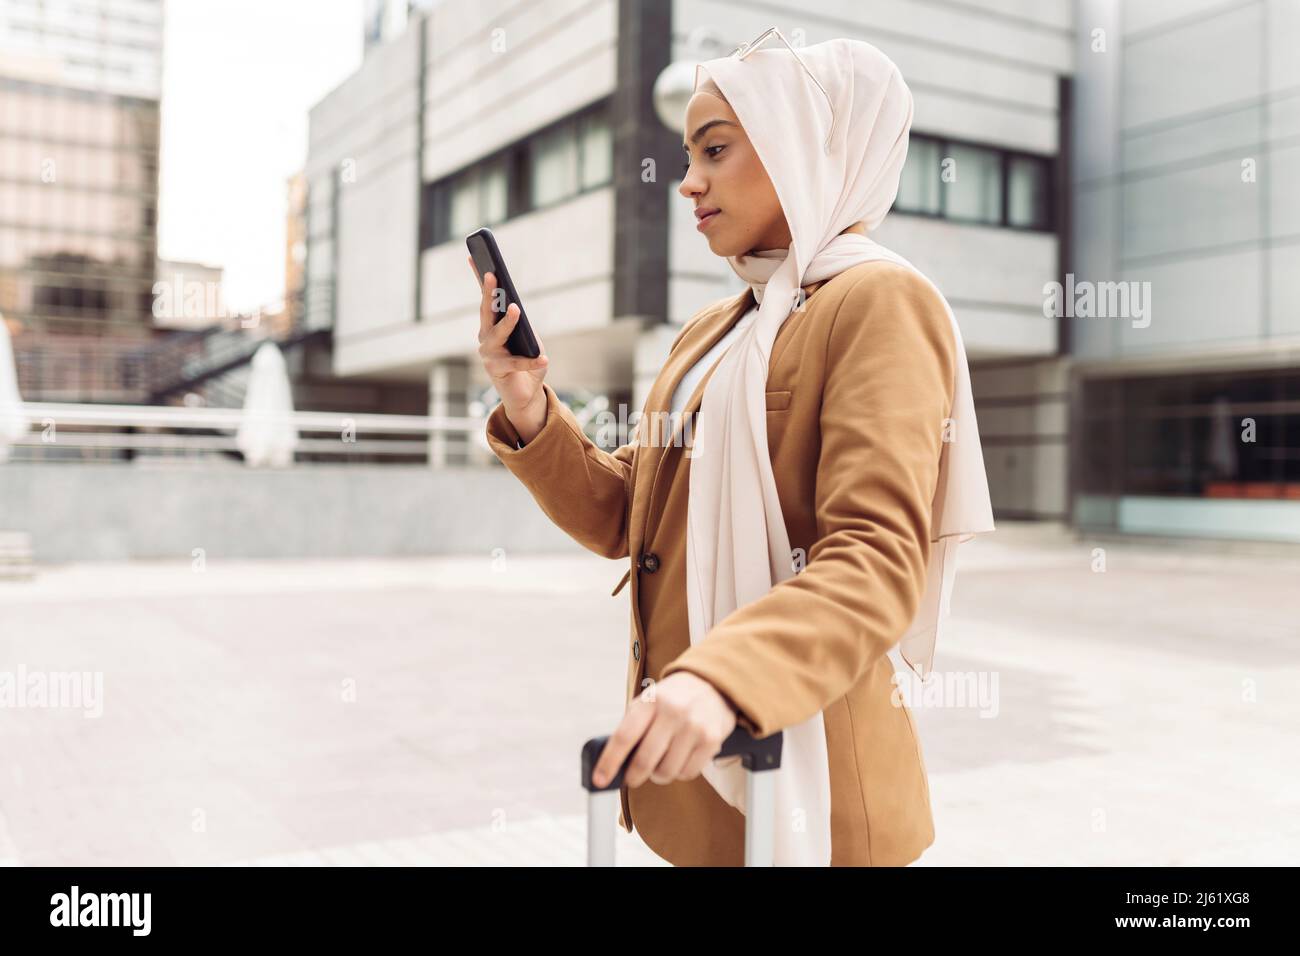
677,92 -> 790,256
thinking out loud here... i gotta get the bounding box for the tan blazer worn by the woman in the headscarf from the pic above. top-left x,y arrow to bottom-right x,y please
488,261 -> 957,866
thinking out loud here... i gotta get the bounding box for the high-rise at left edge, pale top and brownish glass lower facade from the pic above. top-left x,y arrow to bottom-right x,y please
0,0 -> 163,338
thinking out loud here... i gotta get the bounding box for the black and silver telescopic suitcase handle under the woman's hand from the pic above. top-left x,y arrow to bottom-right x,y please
582,727 -> 783,866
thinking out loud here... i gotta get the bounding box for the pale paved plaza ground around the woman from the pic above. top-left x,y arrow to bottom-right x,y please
0,523 -> 1300,865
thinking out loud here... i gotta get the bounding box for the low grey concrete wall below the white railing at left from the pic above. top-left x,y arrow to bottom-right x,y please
0,463 -> 579,562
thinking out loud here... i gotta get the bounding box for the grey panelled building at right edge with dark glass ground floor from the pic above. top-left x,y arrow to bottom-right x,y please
1070,0 -> 1300,542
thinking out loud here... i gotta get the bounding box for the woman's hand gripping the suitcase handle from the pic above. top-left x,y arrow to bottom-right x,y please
593,671 -> 736,787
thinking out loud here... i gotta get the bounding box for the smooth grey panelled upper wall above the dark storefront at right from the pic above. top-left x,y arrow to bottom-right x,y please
1075,0 -> 1300,368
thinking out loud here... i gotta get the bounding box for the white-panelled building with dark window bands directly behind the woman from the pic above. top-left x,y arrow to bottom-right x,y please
307,0 -> 1075,504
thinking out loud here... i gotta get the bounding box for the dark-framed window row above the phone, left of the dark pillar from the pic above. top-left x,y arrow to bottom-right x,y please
421,100 -> 614,248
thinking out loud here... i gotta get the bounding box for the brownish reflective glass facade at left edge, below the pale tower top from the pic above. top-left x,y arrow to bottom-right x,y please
0,77 -> 159,334
